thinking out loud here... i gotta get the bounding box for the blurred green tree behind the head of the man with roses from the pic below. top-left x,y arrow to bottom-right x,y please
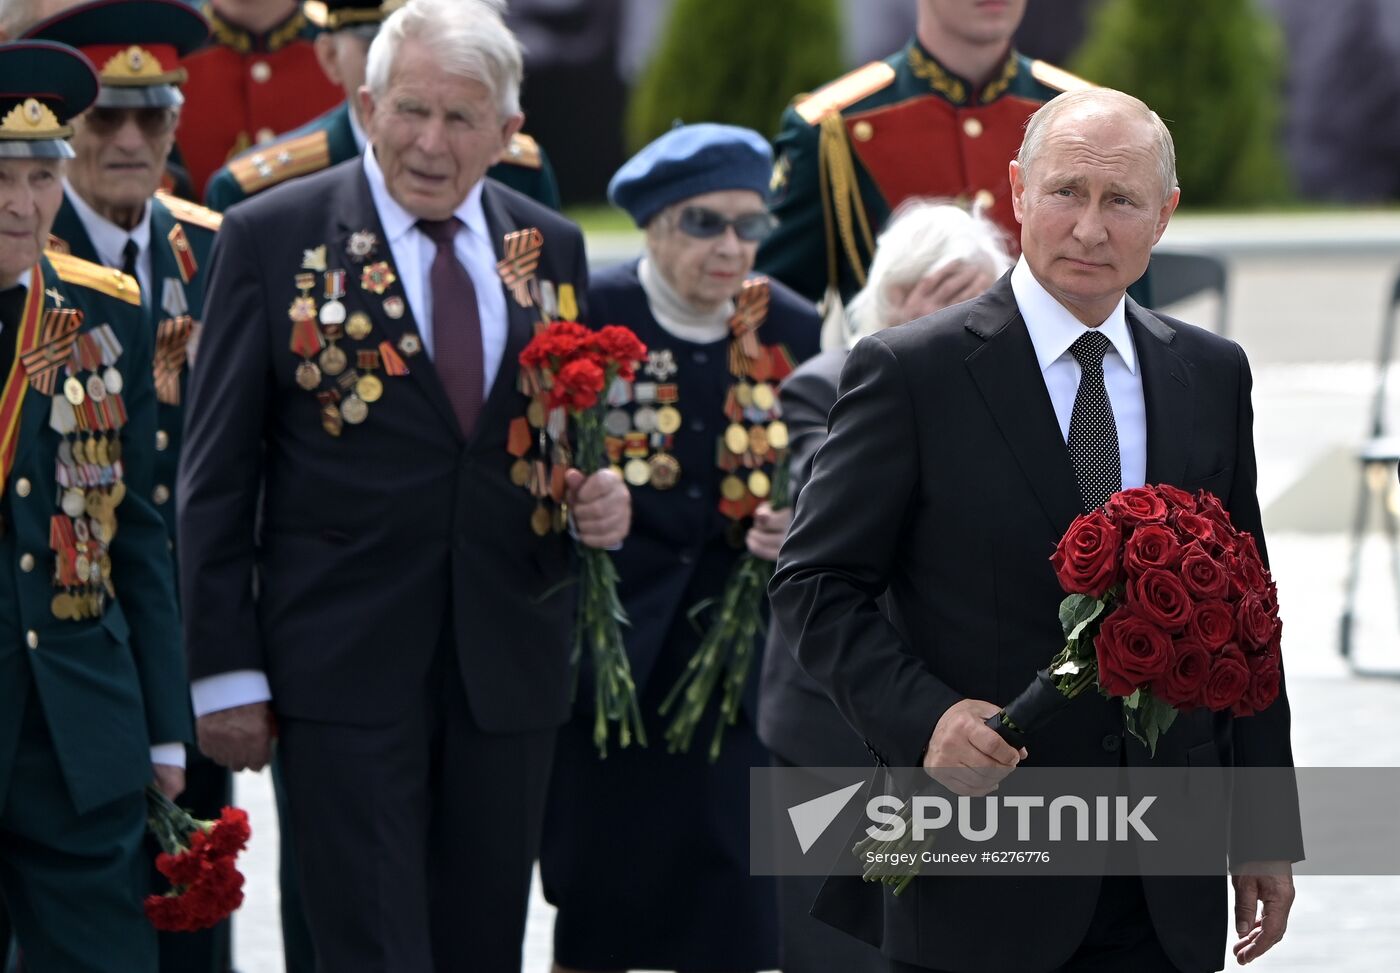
1071,0 -> 1291,209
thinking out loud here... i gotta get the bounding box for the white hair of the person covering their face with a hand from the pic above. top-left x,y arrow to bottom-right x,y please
846,199 -> 1012,344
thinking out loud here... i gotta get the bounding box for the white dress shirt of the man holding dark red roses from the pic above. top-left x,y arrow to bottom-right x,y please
1011,258 -> 1147,490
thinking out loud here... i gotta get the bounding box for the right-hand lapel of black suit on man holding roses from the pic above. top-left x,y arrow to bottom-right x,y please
1127,298 -> 1194,484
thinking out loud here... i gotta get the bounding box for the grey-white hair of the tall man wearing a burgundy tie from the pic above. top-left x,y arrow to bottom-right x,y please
364,0 -> 525,118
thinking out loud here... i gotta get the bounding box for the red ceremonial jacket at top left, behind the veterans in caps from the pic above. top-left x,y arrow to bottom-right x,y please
176,3 -> 344,199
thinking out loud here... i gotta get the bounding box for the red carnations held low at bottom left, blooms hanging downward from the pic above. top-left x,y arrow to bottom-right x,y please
146,785 -> 252,932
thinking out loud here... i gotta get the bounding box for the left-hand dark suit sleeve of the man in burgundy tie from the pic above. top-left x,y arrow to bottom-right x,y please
178,214 -> 273,679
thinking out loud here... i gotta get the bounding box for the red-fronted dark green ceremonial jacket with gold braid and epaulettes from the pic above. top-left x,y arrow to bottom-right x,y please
757,38 -> 1089,302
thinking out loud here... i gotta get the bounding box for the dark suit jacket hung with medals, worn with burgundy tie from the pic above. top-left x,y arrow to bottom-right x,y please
179,158 -> 587,732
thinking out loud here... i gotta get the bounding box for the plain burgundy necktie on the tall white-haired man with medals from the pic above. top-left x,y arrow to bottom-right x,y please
419,217 -> 486,438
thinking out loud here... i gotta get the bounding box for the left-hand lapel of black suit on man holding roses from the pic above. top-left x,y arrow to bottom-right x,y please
965,276 -> 1084,536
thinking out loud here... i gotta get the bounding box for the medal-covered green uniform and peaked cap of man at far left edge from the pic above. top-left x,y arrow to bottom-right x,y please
0,41 -> 192,973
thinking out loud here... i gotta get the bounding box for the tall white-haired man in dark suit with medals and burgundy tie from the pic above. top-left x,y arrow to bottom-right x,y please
179,0 -> 629,973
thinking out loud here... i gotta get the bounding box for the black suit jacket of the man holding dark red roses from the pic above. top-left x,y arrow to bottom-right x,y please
773,276 -> 1301,973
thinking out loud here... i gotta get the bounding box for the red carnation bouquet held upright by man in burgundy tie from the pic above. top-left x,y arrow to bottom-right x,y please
519,321 -> 647,756
